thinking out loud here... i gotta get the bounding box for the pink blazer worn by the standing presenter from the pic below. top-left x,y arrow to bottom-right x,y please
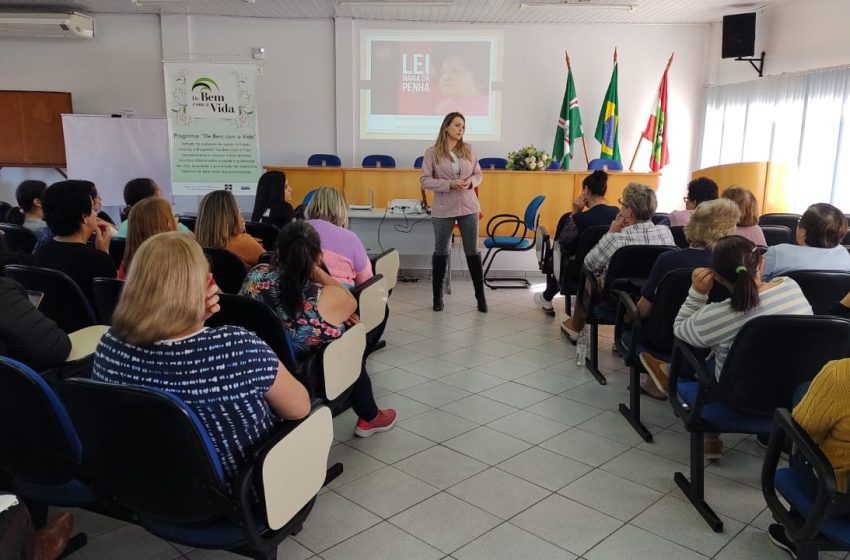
419,144 -> 483,218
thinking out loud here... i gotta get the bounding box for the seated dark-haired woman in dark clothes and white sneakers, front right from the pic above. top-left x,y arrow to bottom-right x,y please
534,170 -> 620,312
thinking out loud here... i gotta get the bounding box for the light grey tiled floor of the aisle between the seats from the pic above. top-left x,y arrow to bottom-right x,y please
59,280 -> 816,560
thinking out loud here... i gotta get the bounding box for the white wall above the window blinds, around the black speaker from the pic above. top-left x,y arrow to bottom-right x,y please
708,0 -> 850,84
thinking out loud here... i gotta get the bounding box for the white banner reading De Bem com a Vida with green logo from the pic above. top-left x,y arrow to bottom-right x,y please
163,62 -> 262,195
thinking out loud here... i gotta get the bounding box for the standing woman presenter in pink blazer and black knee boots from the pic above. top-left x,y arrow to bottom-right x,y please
419,112 -> 487,313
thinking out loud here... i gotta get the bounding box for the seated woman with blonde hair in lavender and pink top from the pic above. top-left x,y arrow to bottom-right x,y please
305,187 -> 372,288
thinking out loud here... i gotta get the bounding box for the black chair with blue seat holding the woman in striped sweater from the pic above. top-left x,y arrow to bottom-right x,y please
668,315 -> 850,533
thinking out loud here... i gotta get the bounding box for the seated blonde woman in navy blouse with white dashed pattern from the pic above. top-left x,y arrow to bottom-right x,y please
92,232 -> 310,481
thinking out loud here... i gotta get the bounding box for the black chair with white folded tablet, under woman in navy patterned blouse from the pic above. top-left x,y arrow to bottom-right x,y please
63,379 -> 342,560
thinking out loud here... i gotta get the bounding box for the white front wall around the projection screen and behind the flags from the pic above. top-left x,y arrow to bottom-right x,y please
337,22 -> 710,210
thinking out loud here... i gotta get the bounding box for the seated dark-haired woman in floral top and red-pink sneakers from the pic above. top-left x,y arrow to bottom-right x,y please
239,222 -> 396,437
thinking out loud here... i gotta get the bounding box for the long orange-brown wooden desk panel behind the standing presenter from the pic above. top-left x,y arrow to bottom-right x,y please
266,166 -> 660,236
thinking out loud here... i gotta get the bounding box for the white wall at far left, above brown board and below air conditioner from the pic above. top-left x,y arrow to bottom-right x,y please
0,15 -> 165,202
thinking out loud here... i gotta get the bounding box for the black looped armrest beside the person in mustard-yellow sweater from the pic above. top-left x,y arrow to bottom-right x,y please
761,408 -> 836,542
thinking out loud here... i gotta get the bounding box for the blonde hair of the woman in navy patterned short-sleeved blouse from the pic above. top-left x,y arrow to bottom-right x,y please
112,232 -> 209,345
